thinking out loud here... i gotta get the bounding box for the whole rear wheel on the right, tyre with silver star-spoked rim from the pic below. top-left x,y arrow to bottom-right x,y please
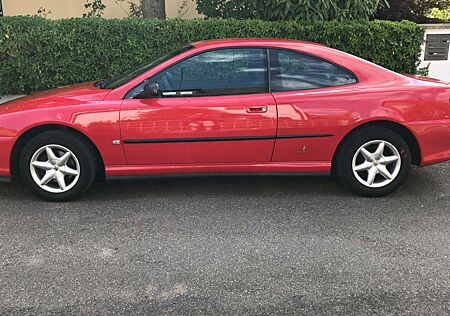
336,127 -> 411,197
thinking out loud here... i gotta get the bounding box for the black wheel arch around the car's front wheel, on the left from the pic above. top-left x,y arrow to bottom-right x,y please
10,124 -> 105,180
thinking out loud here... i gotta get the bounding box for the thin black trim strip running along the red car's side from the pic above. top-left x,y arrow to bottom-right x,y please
123,134 -> 334,144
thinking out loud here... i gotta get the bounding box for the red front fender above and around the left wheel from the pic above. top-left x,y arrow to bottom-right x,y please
0,101 -> 126,175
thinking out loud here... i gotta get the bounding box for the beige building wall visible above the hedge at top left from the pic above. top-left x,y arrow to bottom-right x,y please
1,0 -> 200,19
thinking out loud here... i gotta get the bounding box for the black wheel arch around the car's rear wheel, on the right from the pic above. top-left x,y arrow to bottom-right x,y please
331,120 -> 421,173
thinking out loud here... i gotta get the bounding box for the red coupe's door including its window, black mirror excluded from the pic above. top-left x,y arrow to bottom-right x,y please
120,48 -> 277,165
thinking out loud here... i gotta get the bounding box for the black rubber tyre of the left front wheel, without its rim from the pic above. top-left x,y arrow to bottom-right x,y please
19,130 -> 98,202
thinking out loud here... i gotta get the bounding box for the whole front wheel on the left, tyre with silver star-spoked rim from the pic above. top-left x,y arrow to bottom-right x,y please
19,130 -> 98,202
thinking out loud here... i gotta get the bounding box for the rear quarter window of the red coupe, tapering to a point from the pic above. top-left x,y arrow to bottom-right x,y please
270,49 -> 357,92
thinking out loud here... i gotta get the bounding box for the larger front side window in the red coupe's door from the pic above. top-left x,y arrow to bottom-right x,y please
151,48 -> 268,96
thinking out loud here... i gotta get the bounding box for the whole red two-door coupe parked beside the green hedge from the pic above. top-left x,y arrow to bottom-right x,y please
0,39 -> 450,201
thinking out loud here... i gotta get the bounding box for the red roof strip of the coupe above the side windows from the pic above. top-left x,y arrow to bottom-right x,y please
192,38 -> 325,48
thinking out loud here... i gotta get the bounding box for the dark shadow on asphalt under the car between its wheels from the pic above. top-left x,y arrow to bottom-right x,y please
87,175 -> 347,199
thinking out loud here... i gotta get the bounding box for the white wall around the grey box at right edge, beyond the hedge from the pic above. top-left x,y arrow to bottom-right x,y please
420,23 -> 450,82
